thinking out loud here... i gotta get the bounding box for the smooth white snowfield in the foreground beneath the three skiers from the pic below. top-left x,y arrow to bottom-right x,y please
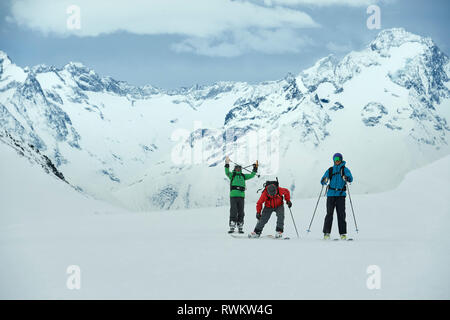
0,140 -> 450,299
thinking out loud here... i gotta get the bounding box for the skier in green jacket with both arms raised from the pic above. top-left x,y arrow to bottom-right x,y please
225,156 -> 258,233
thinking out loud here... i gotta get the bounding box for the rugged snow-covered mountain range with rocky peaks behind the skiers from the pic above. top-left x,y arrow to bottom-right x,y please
0,29 -> 450,210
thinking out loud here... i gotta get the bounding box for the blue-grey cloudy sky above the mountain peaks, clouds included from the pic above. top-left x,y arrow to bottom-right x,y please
0,0 -> 450,88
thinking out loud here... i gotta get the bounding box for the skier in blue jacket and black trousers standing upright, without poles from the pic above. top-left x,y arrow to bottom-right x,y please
320,153 -> 353,240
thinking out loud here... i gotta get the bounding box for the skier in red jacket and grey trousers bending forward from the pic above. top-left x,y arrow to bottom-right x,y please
248,181 -> 292,238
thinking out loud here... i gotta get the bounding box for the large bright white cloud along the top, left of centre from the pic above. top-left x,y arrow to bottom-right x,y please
10,0 -> 319,56
